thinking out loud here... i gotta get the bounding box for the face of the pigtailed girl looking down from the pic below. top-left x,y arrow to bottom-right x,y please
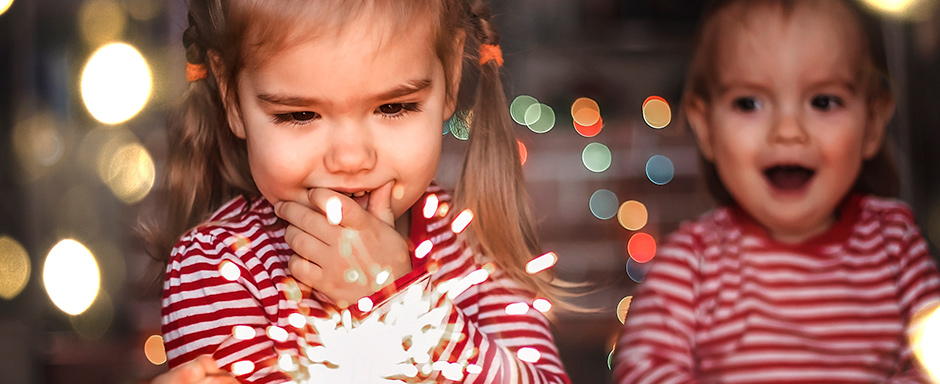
230,15 -> 459,222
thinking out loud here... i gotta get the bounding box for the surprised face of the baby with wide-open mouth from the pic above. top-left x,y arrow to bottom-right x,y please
689,2 -> 890,243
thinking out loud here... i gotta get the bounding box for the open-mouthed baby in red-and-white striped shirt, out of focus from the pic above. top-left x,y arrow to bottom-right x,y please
615,0 -> 940,383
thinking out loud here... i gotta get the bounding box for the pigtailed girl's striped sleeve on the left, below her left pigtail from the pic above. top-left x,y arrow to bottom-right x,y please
162,229 -> 289,383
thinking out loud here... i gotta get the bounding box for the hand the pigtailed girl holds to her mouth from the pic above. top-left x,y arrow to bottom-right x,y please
276,181 -> 411,307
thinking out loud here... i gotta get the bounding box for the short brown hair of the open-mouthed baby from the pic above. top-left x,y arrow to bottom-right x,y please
682,0 -> 900,205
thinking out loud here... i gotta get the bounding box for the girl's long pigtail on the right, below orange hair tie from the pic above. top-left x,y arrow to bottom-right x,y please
455,0 -> 560,306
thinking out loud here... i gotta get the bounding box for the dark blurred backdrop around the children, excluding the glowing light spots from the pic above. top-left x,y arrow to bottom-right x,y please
0,0 -> 940,383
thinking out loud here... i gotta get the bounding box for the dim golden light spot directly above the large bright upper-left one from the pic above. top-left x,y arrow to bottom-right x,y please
78,0 -> 126,46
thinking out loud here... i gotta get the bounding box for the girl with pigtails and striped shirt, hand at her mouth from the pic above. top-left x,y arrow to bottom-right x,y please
151,0 -> 568,383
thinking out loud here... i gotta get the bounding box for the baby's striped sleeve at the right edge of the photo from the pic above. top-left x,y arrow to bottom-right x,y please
885,202 -> 940,384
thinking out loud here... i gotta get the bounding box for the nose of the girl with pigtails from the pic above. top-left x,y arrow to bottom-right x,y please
323,124 -> 376,174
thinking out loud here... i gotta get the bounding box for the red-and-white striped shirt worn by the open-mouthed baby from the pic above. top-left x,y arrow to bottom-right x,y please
614,196 -> 940,384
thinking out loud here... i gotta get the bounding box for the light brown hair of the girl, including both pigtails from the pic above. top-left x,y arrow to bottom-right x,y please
144,0 -> 559,304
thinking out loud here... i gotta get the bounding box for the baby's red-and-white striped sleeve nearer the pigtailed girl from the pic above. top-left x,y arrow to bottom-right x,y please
614,222 -> 698,384
